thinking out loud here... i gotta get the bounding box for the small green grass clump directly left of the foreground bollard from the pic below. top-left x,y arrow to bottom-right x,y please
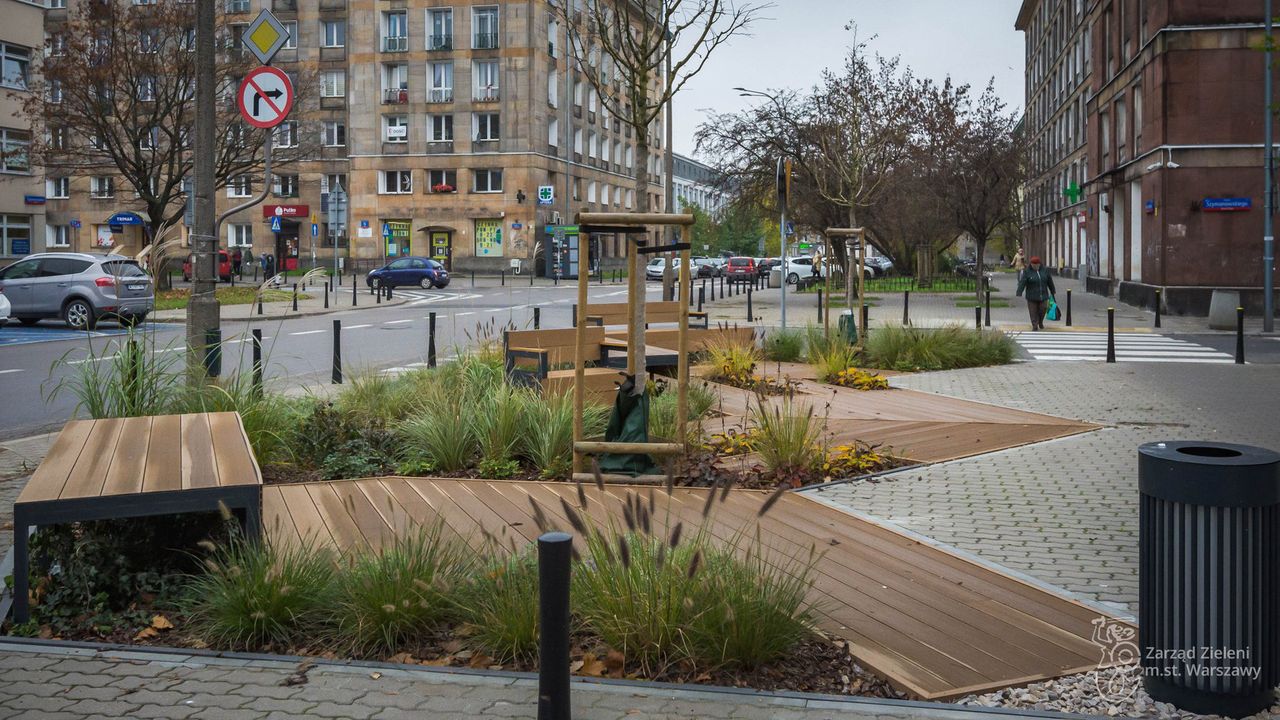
461,551 -> 538,662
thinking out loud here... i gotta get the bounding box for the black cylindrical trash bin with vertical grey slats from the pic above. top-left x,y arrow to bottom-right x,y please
1138,441 -> 1280,717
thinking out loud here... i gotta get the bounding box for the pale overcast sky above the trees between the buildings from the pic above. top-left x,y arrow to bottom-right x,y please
672,0 -> 1025,156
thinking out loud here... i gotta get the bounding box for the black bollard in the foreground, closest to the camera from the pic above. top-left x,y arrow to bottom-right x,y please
538,533 -> 573,720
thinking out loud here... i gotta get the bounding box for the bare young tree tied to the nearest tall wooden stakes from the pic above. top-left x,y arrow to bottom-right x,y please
554,0 -> 763,375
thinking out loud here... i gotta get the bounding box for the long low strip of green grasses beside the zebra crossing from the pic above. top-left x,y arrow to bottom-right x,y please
865,325 -> 1015,370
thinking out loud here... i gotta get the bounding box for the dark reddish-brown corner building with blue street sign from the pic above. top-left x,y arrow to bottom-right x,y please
1018,0 -> 1266,314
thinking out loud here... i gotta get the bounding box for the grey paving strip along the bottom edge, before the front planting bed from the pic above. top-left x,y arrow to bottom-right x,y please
0,643 -> 1071,720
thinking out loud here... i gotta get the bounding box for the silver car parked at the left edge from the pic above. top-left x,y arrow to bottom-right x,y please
0,252 -> 155,331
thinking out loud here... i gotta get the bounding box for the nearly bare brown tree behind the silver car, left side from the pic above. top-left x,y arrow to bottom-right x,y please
23,0 -> 319,279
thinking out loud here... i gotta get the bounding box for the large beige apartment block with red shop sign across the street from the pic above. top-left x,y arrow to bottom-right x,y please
49,0 -> 663,272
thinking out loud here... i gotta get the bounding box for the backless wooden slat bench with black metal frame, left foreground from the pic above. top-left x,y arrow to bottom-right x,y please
13,413 -> 262,623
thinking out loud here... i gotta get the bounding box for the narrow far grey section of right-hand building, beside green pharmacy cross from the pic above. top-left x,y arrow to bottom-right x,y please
1015,0 -> 1092,280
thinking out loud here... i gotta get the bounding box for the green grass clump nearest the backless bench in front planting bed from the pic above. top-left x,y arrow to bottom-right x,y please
186,538 -> 334,650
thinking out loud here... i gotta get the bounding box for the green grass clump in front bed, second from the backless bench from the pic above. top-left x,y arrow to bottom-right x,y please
332,520 -> 472,655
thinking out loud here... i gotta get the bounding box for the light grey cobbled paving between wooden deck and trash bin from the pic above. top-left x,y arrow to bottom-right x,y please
814,363 -> 1280,614
